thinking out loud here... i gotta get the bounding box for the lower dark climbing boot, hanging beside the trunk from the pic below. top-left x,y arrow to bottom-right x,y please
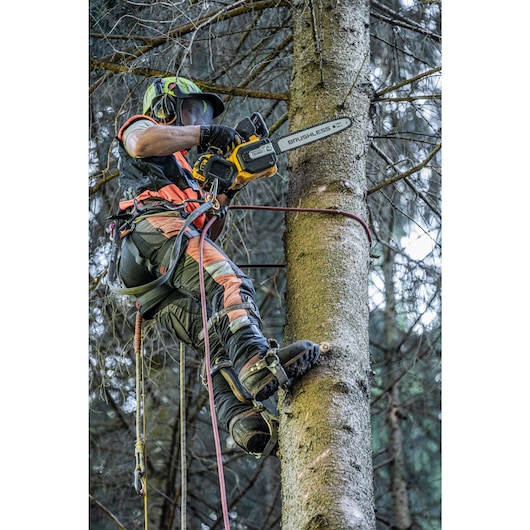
228,409 -> 278,457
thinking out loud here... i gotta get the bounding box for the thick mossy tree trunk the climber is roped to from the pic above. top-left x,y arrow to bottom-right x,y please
280,0 -> 375,530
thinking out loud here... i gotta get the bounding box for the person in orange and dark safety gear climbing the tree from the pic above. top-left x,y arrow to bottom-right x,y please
113,77 -> 320,456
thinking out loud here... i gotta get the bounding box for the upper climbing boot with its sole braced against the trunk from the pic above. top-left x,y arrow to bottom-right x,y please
239,340 -> 320,401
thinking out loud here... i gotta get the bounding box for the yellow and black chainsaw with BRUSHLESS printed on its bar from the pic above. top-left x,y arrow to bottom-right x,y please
192,112 -> 352,193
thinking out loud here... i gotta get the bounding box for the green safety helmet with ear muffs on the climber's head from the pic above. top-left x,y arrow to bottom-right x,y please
143,76 -> 225,125
